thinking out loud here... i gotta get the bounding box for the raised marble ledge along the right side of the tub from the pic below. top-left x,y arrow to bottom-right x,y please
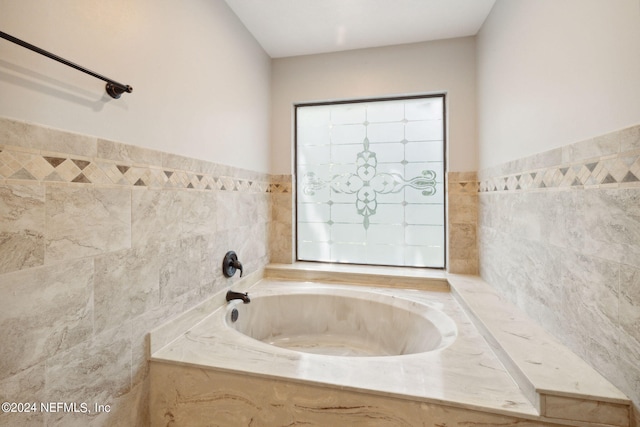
448,275 -> 630,425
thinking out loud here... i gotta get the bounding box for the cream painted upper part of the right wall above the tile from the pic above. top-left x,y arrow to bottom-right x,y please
477,0 -> 640,169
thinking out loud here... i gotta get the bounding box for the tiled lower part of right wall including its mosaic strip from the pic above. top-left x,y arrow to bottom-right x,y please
478,126 -> 640,418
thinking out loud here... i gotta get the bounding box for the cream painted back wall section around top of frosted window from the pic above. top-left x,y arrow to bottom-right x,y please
271,37 -> 477,174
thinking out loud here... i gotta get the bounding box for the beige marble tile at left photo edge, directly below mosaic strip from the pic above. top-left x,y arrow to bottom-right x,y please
0,184 -> 45,274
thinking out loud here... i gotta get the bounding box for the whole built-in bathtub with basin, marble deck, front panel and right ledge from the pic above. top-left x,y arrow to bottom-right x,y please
149,272 -> 630,427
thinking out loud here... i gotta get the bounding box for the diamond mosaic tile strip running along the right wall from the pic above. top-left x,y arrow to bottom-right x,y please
478,151 -> 640,192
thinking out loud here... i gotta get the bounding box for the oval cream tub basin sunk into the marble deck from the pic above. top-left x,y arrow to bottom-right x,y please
226,288 -> 457,356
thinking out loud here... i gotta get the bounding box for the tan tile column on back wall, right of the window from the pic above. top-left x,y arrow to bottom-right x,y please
446,172 -> 478,274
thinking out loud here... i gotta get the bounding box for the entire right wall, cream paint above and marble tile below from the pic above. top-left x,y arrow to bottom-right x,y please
477,0 -> 640,420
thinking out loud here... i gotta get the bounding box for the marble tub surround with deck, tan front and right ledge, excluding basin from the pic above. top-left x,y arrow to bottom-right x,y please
151,263 -> 630,426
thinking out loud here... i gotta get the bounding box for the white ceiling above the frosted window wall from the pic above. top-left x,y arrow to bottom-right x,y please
225,0 -> 495,58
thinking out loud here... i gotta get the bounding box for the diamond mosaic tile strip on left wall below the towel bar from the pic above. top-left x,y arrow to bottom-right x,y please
0,146 -> 291,193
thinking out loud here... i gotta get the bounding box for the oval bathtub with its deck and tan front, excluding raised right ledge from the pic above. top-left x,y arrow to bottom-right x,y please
151,279 -> 536,425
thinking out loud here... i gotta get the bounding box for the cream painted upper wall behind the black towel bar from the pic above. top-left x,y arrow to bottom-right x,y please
0,0 -> 271,172
